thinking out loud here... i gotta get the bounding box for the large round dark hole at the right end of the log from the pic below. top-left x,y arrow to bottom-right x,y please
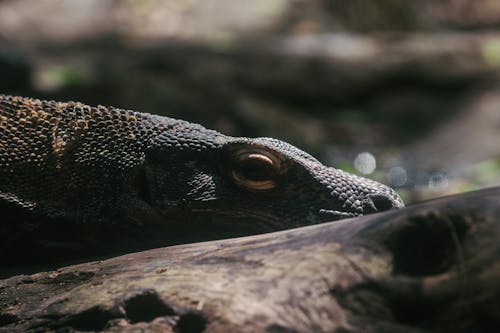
388,215 -> 469,276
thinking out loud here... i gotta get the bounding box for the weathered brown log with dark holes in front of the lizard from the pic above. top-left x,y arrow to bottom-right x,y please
0,188 -> 500,333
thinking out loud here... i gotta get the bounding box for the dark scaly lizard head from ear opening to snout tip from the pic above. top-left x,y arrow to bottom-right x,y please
146,131 -> 404,230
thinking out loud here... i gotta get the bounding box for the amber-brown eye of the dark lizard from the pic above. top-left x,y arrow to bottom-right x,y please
231,152 -> 280,190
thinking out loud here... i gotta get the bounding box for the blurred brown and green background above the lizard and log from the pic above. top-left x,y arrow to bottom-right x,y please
0,0 -> 500,203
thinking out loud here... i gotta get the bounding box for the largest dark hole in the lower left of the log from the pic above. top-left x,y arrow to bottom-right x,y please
124,289 -> 175,323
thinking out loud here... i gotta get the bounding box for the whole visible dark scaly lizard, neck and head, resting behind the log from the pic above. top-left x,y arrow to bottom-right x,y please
0,95 -> 403,230
